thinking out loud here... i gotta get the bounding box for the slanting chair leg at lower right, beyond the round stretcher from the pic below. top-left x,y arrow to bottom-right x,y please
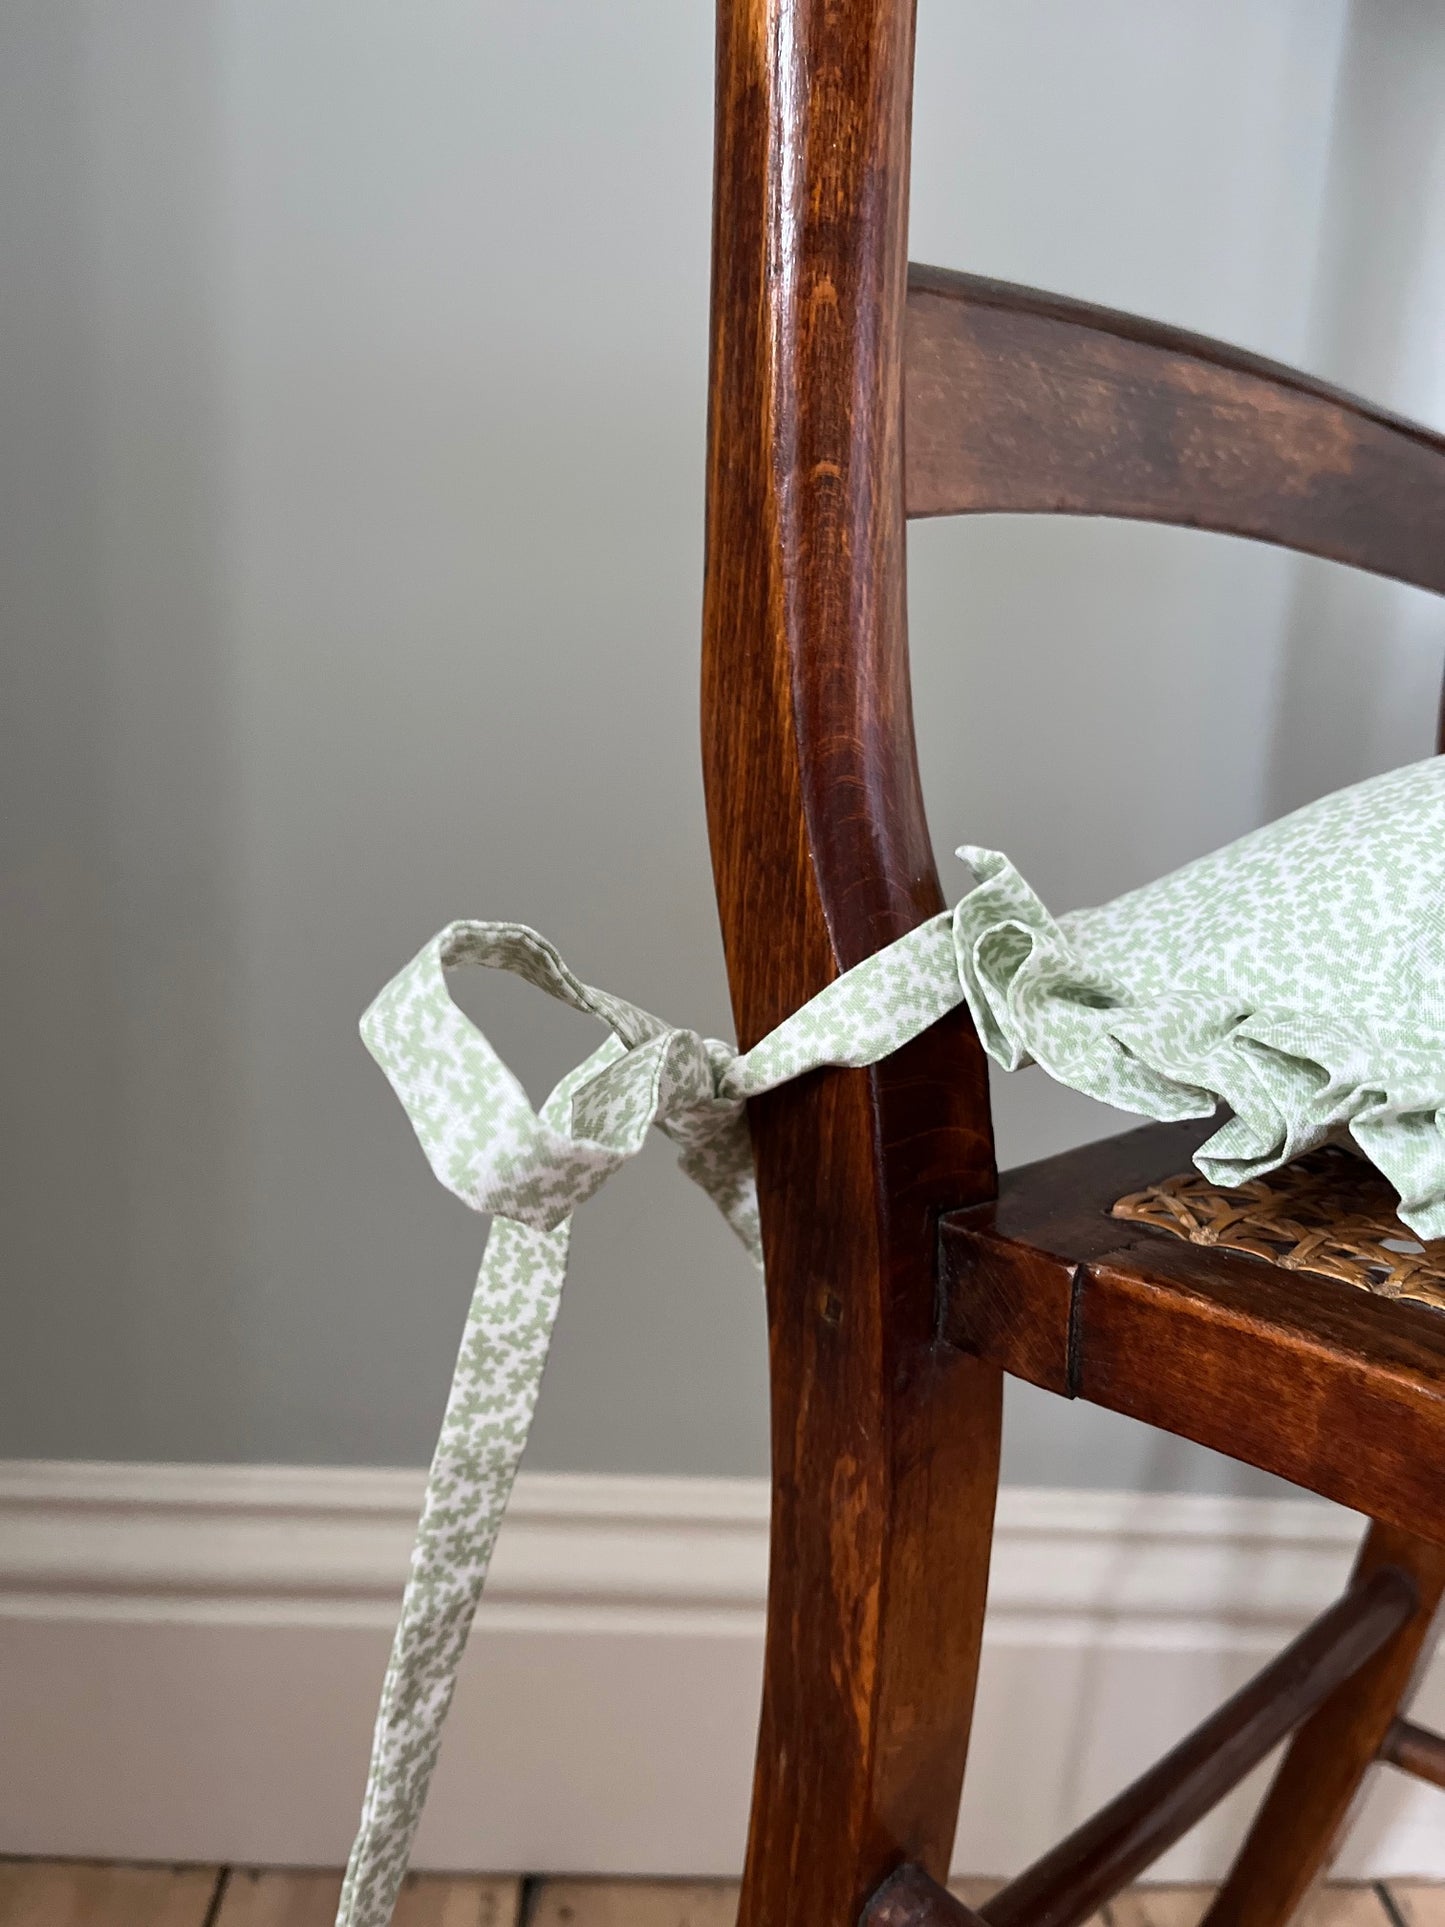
1204,1524 -> 1445,1927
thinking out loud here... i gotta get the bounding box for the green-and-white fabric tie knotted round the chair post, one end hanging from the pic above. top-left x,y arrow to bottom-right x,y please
337,913 -> 965,1927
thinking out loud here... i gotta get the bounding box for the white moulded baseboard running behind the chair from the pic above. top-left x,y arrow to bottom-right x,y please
0,1463 -> 1445,1879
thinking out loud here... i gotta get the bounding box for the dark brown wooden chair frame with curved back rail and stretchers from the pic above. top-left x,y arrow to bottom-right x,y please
703,0 -> 1445,1927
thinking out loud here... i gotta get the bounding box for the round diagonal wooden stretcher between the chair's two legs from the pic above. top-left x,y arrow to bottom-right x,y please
979,1561 -> 1418,1927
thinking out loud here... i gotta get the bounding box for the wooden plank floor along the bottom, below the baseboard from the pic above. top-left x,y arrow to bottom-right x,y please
0,1860 -> 1445,1927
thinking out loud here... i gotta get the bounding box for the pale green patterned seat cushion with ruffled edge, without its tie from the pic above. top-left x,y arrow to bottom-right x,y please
954,757 -> 1445,1239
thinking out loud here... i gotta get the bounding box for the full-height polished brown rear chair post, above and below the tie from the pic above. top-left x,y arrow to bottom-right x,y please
703,0 -> 1000,1927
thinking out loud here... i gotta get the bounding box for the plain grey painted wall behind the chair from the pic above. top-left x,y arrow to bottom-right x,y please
0,0 -> 1445,1486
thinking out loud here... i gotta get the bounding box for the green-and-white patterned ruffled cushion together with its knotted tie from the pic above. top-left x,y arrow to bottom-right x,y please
337,757 -> 1445,1927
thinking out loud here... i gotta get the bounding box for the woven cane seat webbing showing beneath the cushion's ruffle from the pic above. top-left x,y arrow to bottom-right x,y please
1112,1147 -> 1445,1310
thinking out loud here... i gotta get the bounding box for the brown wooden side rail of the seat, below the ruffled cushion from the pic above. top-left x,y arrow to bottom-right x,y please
940,1120 -> 1445,1542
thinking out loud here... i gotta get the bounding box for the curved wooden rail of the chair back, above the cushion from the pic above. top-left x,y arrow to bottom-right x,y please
904,266 -> 1445,594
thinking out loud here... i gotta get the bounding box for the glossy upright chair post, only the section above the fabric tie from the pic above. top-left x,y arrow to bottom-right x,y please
703,0 -> 963,1017
